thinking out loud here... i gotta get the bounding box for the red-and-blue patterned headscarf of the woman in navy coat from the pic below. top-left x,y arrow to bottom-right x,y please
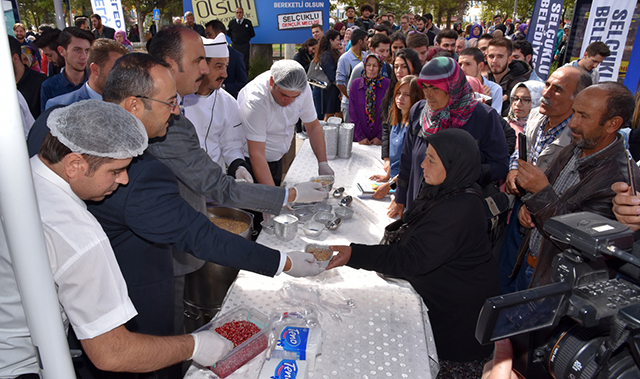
418,57 -> 478,138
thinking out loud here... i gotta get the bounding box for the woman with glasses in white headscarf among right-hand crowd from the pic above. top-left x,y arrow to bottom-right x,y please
505,80 -> 544,149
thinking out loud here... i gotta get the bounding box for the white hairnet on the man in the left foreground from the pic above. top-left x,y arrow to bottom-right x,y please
47,100 -> 149,159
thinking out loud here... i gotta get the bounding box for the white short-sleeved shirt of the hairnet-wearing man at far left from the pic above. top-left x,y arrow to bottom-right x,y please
0,155 -> 137,377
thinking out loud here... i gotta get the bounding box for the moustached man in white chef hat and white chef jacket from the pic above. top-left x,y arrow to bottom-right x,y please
184,33 -> 253,183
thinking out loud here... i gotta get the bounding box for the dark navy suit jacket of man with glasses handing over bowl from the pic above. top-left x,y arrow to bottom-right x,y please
88,152 -> 280,335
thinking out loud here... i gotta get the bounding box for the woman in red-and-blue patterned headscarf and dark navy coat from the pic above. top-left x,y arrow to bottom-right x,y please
388,57 -> 509,217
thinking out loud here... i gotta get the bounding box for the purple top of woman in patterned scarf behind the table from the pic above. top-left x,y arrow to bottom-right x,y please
349,78 -> 389,142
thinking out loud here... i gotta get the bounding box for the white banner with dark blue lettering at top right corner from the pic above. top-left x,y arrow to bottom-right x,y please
580,0 -> 636,82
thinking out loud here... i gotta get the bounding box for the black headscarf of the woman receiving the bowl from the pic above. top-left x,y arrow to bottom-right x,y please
402,129 -> 481,222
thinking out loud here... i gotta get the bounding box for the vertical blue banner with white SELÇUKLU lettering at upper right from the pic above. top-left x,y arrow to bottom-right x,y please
527,0 -> 564,80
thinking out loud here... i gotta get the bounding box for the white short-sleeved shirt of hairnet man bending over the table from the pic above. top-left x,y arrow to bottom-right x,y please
238,71 -> 318,162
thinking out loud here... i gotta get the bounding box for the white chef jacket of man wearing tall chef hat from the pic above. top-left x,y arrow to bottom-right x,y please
184,88 -> 245,168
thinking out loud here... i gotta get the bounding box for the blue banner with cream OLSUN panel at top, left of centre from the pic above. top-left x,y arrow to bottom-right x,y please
182,0 -> 329,44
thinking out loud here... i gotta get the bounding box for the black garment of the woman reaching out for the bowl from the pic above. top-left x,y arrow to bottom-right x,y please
348,193 -> 500,361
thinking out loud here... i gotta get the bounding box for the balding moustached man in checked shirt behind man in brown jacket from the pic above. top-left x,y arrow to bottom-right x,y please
499,67 -> 591,292
